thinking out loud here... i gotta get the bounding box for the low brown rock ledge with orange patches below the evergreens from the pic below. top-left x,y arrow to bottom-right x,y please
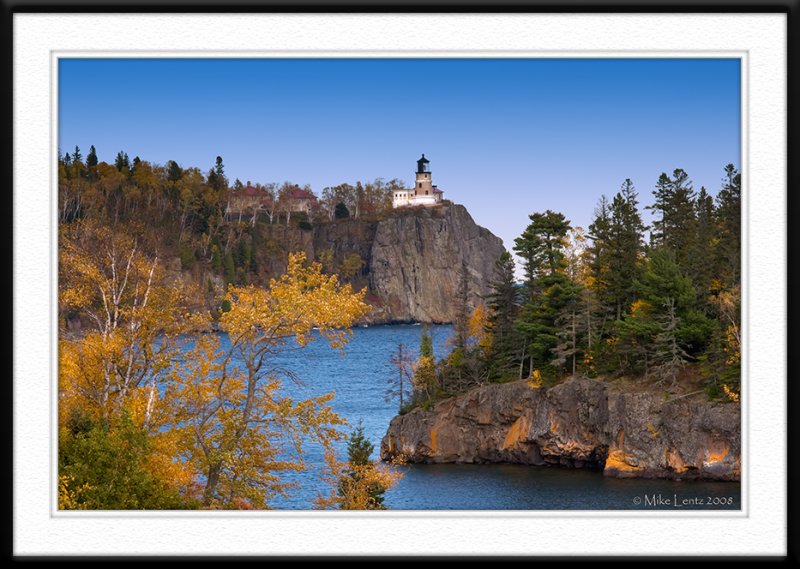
381,379 -> 741,480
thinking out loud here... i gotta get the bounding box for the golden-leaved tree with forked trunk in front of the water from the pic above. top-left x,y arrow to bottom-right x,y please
169,253 -> 369,508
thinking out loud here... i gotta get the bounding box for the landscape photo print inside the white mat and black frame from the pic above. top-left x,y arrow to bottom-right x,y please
57,57 -> 746,511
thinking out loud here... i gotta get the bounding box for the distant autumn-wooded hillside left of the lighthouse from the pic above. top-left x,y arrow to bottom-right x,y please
58,146 -> 402,307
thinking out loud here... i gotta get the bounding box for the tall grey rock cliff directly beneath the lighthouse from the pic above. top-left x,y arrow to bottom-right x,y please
247,204 -> 504,323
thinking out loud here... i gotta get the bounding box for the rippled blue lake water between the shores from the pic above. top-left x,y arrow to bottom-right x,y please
217,325 -> 741,510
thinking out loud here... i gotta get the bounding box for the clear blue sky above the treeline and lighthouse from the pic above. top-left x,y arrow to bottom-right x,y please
59,59 -> 741,272
